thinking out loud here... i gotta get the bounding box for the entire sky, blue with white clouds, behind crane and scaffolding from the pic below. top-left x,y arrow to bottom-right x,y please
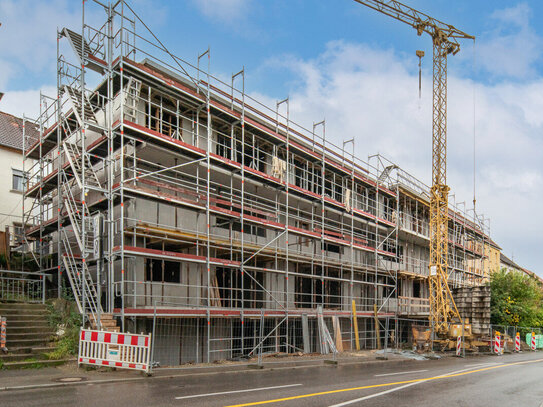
0,0 -> 543,275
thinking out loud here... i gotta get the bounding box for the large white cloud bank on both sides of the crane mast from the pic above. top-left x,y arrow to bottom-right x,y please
255,42 -> 543,274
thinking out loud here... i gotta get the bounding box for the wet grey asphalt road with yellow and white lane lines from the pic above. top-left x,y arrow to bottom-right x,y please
4,352 -> 543,407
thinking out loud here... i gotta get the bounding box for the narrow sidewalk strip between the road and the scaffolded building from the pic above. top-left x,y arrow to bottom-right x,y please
0,351 -> 442,391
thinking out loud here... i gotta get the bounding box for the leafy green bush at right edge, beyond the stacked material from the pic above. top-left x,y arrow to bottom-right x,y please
490,269 -> 543,327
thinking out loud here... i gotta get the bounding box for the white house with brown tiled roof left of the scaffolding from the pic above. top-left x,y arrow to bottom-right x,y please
0,112 -> 39,253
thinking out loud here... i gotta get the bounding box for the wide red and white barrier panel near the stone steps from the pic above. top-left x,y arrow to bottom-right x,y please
78,329 -> 151,373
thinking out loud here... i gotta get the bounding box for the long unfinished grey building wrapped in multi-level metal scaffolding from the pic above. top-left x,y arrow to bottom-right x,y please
23,1 -> 488,365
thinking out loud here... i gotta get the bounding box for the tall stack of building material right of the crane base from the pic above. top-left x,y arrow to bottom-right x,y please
452,286 -> 490,335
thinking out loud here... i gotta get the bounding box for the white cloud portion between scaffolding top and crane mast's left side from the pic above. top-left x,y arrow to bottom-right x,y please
255,41 -> 431,178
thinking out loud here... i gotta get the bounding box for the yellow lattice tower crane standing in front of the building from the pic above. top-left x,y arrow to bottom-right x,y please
355,0 -> 475,336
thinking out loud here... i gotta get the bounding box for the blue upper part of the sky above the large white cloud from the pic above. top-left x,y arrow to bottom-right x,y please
6,0 -> 543,98
